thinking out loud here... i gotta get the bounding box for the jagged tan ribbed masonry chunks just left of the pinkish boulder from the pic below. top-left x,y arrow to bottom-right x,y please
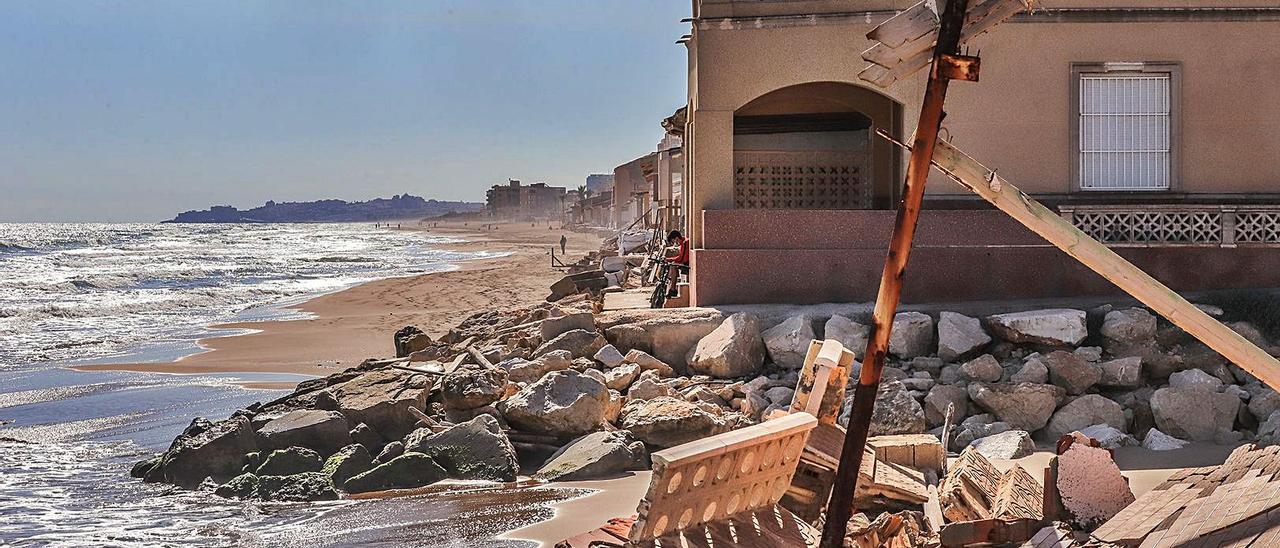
938,447 -> 1044,521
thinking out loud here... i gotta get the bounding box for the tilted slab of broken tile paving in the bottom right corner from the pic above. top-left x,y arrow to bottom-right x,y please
1092,446 -> 1280,548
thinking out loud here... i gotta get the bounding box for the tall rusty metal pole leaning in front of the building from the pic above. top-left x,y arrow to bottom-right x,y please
822,0 -> 977,548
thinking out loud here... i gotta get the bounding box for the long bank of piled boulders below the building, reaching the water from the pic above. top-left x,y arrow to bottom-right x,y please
133,300 -> 1280,512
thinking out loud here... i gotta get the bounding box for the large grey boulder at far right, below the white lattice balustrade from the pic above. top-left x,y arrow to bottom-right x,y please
1151,388 -> 1240,442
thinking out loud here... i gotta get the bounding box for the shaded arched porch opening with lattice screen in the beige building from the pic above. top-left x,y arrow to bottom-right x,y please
733,82 -> 902,209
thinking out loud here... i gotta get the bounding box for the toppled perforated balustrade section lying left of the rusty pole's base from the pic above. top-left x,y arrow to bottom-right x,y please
630,412 -> 818,545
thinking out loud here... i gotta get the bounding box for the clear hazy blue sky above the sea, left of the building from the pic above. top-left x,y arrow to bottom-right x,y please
0,0 -> 690,222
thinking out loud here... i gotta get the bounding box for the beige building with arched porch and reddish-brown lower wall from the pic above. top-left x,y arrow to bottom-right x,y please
684,0 -> 1280,305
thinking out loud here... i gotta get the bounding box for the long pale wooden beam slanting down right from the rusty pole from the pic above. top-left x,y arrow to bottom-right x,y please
877,131 -> 1280,391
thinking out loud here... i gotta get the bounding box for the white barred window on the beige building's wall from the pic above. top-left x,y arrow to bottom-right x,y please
1079,73 -> 1171,191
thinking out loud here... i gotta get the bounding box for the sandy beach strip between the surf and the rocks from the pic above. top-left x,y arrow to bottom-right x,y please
78,222 -> 600,378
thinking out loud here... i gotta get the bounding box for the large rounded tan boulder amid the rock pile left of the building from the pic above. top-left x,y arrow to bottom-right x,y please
498,370 -> 609,438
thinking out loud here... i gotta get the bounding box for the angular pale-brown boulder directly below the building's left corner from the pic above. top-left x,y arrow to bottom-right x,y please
689,312 -> 765,379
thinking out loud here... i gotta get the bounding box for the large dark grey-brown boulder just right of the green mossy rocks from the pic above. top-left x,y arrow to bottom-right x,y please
404,415 -> 520,481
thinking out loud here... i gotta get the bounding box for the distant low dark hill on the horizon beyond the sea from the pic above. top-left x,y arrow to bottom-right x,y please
165,195 -> 484,223
